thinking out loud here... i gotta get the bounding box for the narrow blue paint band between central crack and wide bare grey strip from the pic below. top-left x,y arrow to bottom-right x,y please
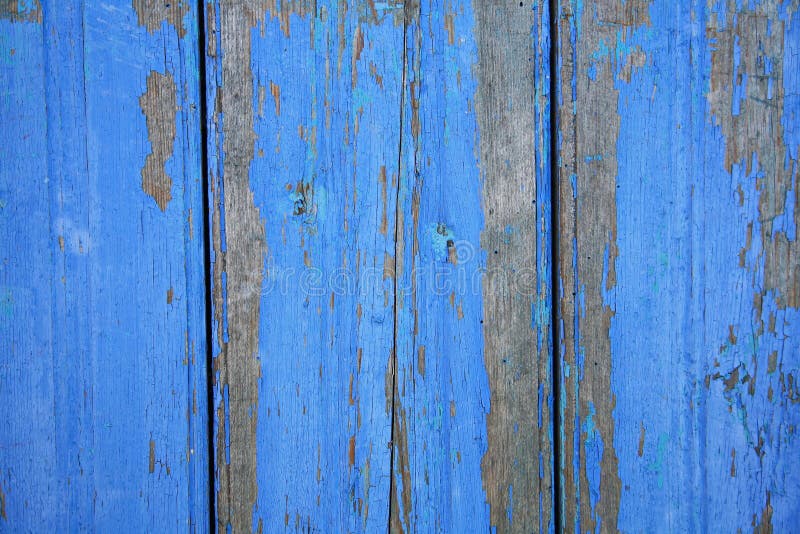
394,1 -> 520,532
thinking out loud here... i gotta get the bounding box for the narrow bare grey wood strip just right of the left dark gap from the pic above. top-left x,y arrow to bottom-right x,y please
209,1 -> 267,532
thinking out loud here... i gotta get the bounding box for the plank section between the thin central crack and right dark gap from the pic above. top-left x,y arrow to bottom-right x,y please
390,0 -> 554,532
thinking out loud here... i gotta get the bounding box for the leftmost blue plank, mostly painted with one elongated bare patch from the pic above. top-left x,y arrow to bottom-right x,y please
0,0 -> 209,532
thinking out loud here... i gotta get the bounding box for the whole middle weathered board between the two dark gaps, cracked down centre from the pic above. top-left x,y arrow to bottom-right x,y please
206,0 -> 553,532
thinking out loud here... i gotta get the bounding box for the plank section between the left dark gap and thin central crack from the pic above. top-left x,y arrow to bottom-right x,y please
206,0 -> 403,532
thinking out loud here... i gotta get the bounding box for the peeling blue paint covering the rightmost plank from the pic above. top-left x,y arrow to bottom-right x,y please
608,0 -> 800,531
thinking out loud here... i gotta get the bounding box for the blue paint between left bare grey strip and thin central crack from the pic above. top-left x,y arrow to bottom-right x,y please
207,0 -> 402,532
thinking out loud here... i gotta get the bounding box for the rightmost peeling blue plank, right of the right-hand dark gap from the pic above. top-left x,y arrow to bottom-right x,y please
557,0 -> 800,532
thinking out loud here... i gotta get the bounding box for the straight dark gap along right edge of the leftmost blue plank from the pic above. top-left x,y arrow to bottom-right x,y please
196,0 -> 217,532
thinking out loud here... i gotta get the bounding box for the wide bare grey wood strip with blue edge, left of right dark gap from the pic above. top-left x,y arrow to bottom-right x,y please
472,1 -> 555,532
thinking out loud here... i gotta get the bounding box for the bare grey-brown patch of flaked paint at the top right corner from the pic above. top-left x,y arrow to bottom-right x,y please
706,0 -> 800,315
